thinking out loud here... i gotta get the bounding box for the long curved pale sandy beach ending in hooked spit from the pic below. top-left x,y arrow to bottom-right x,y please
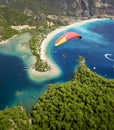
29,18 -> 103,81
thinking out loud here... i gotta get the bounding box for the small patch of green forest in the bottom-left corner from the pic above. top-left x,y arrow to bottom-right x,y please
0,107 -> 31,130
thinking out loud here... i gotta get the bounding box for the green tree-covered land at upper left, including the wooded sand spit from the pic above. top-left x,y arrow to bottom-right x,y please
0,6 -> 66,72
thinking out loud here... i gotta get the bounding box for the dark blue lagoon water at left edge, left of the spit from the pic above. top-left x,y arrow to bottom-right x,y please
0,54 -> 33,109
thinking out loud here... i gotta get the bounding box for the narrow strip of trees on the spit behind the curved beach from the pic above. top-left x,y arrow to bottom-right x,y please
29,20 -> 56,72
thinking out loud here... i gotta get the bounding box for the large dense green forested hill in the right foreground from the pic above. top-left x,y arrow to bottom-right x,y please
32,64 -> 114,130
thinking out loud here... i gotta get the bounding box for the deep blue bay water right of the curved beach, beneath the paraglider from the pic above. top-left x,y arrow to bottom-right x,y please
49,20 -> 114,81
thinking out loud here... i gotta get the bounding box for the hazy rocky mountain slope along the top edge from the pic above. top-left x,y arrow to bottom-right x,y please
0,0 -> 114,19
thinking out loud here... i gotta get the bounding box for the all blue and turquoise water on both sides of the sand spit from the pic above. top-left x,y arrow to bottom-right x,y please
0,19 -> 114,111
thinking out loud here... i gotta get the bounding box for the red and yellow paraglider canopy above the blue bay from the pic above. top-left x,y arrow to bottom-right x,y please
55,32 -> 82,46
